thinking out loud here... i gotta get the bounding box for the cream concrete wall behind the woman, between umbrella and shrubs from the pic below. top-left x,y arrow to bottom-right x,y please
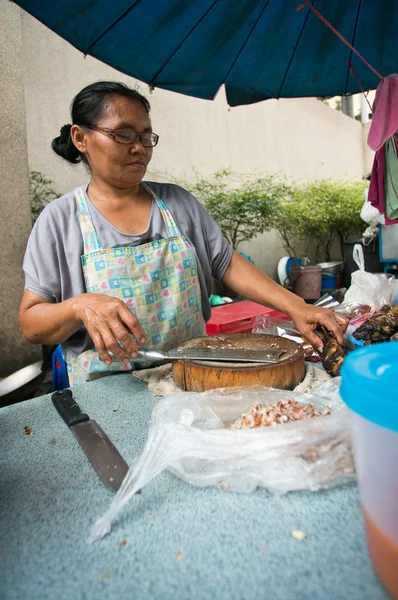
22,13 -> 364,276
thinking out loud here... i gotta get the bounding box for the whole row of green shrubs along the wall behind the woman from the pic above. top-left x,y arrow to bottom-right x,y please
155,170 -> 367,262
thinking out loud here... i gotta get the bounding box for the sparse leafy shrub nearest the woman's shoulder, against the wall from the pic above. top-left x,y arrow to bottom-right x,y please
170,170 -> 289,250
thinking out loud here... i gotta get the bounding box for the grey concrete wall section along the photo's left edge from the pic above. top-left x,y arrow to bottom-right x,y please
0,0 -> 40,377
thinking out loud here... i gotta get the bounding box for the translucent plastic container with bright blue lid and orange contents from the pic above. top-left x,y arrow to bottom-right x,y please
340,342 -> 398,600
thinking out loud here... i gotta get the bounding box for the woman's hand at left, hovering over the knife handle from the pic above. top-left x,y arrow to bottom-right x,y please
73,294 -> 145,365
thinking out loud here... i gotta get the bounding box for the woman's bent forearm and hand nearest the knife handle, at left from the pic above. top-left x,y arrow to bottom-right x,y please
19,290 -> 145,364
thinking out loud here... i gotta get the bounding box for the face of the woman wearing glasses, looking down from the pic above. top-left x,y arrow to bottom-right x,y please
75,96 -> 153,189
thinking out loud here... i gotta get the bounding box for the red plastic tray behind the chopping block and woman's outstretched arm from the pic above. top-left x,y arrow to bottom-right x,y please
206,300 -> 290,335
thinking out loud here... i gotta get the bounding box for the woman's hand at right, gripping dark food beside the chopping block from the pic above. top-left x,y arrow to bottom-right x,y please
289,303 -> 348,349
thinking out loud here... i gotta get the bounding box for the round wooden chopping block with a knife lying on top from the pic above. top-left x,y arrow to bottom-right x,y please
172,333 -> 305,392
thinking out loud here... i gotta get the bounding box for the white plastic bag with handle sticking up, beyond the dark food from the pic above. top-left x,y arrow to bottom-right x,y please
342,244 -> 394,311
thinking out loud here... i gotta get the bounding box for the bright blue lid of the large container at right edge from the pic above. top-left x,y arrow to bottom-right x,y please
340,342 -> 398,431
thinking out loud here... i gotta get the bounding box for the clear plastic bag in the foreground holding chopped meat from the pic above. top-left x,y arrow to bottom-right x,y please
92,378 -> 354,539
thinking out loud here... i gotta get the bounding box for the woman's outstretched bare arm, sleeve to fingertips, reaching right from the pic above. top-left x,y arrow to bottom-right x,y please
222,252 -> 348,348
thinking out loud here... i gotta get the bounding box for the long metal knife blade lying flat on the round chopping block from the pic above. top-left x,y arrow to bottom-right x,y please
133,348 -> 285,363
